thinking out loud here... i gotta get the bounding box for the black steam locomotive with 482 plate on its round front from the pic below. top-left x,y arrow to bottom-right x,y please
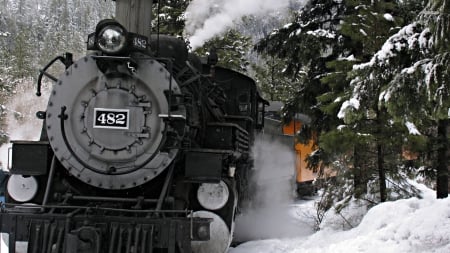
0,20 -> 267,253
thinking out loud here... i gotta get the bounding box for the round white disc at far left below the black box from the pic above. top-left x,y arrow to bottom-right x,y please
6,174 -> 38,202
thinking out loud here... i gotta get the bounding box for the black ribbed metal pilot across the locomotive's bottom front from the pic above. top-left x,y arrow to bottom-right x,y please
0,209 -> 210,253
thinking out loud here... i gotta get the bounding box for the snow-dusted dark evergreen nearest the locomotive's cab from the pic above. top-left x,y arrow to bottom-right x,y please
256,0 -> 345,126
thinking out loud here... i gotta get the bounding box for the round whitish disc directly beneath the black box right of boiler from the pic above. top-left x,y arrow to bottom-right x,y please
197,181 -> 230,210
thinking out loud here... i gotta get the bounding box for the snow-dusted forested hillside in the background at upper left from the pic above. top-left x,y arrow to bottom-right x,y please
0,0 -> 114,145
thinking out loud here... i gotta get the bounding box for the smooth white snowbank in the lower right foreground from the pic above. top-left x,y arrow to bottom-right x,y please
229,185 -> 450,253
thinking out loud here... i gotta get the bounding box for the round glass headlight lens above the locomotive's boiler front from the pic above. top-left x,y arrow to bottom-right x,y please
97,25 -> 127,54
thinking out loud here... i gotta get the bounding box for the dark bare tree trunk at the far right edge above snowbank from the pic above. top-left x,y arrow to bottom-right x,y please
436,119 -> 449,199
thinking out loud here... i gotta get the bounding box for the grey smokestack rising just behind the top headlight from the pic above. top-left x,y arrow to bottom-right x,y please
116,0 -> 153,38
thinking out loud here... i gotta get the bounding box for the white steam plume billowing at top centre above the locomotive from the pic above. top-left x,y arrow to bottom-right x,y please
185,0 -> 290,49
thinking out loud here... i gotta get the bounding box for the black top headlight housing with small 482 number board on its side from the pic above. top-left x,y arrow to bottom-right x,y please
87,19 -> 149,55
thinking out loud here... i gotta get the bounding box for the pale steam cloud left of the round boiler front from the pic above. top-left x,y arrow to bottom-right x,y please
0,79 -> 49,169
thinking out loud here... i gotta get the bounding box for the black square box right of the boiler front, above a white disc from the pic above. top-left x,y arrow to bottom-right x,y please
185,151 -> 223,183
